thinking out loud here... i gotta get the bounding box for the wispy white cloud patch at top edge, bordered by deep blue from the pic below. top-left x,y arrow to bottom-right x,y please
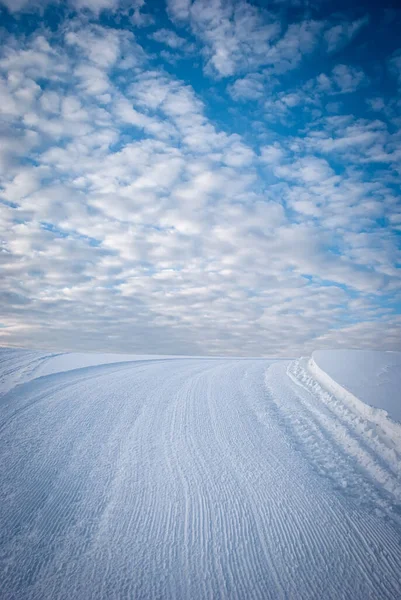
168,0 -> 323,77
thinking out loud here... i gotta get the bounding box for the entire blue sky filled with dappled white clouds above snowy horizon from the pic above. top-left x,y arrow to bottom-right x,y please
0,0 -> 401,356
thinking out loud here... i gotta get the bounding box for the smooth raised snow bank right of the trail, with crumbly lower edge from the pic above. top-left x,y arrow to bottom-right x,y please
308,350 -> 401,424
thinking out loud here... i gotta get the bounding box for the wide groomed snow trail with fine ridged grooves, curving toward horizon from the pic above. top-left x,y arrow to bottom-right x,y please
0,359 -> 401,600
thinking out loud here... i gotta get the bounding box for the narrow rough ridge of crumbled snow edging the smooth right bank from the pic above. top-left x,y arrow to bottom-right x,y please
306,356 -> 401,447
